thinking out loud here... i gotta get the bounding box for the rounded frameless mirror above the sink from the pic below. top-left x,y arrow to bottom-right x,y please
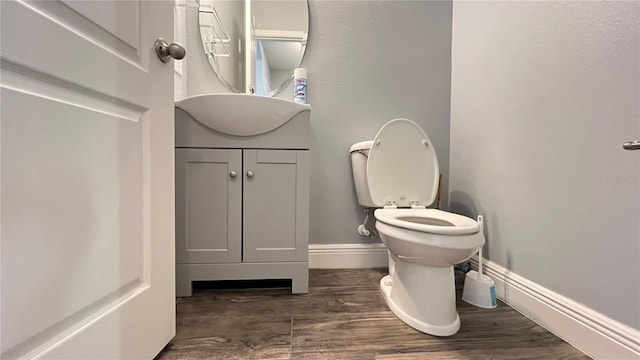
199,0 -> 309,96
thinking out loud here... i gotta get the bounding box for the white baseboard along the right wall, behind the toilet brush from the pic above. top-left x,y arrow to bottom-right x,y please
471,256 -> 640,360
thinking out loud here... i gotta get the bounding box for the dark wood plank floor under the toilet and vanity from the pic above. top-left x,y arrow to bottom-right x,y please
156,269 -> 589,360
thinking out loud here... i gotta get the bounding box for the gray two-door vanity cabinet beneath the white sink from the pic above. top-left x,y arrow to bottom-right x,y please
175,95 -> 310,296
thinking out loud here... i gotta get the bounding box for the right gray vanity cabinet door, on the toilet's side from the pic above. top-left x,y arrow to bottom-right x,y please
242,150 -> 309,262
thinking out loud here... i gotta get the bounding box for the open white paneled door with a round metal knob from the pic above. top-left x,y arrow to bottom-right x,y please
0,0 -> 175,359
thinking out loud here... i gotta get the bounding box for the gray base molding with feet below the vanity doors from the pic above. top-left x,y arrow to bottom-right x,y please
176,261 -> 309,297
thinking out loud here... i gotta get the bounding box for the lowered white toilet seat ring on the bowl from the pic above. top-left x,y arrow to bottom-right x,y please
375,209 -> 480,235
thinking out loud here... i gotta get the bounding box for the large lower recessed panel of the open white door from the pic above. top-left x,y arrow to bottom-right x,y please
2,89 -> 143,347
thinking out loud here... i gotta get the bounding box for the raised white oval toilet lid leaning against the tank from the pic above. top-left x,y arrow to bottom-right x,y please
367,119 -> 440,207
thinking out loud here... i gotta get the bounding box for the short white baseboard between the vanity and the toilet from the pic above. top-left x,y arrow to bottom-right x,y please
309,243 -> 389,269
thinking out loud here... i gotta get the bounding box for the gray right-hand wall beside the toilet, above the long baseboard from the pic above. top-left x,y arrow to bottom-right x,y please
450,2 -> 640,329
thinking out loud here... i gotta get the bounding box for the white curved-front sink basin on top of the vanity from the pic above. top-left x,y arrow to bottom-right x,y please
175,94 -> 311,136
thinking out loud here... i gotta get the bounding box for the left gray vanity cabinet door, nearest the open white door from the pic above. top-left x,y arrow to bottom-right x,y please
176,149 -> 242,264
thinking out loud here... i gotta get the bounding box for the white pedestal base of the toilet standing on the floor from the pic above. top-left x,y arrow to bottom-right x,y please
380,261 -> 460,336
